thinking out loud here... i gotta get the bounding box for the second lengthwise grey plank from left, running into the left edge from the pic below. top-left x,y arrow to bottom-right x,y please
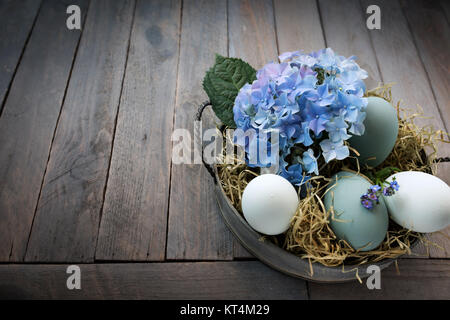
0,1 -> 87,261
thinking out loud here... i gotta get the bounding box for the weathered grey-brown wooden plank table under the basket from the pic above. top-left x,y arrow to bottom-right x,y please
0,0 -> 450,299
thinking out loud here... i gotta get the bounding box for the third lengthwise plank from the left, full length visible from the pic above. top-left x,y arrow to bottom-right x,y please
25,0 -> 134,261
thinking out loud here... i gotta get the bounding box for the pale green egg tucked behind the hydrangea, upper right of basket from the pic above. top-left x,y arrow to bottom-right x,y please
348,97 -> 398,167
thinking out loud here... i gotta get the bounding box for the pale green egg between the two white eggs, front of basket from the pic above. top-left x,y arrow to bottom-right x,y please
324,171 -> 389,251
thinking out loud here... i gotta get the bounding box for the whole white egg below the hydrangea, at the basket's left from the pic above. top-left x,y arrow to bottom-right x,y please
242,174 -> 298,235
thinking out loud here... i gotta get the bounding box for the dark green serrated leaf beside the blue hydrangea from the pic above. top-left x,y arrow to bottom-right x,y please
203,54 -> 256,128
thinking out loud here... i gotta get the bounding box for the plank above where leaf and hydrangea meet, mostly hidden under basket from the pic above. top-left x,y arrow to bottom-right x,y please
228,0 -> 278,258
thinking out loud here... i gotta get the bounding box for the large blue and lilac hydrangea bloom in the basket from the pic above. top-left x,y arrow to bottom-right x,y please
233,48 -> 367,185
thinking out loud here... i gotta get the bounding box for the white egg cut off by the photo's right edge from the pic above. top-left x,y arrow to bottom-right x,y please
384,171 -> 450,233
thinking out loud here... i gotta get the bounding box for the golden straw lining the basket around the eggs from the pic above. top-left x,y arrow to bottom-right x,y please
217,84 -> 449,273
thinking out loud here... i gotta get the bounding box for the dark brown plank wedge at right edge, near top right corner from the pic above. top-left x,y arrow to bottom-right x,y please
402,0 -> 450,131
